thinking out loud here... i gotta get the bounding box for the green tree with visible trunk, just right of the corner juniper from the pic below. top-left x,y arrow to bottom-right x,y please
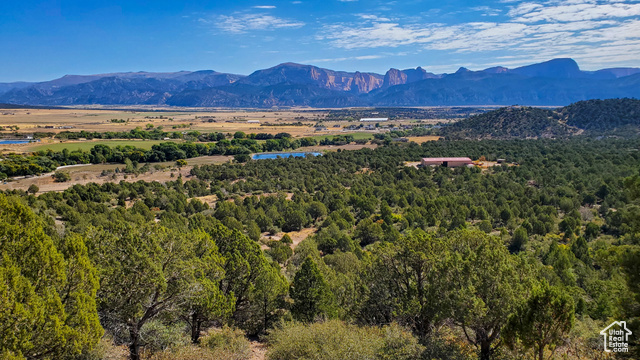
88,224 -> 198,360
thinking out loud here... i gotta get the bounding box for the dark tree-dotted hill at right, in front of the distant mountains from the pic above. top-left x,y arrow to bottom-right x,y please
442,99 -> 640,139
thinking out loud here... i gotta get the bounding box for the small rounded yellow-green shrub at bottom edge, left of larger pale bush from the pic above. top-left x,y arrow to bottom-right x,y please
202,326 -> 251,360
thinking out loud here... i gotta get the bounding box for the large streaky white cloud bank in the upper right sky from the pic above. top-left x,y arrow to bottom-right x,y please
316,0 -> 640,66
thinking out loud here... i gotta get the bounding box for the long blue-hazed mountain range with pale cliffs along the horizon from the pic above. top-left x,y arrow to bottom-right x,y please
0,59 -> 640,108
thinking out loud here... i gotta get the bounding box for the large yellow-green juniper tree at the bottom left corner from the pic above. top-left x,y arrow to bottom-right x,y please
0,195 -> 102,359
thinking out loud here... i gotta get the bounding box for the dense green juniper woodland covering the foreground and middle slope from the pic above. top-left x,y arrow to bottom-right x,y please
0,139 -> 640,359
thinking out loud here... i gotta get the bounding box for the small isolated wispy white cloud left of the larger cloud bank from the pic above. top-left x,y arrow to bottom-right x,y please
205,14 -> 305,34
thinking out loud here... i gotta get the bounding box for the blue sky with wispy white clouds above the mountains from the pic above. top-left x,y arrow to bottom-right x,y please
0,0 -> 640,82
